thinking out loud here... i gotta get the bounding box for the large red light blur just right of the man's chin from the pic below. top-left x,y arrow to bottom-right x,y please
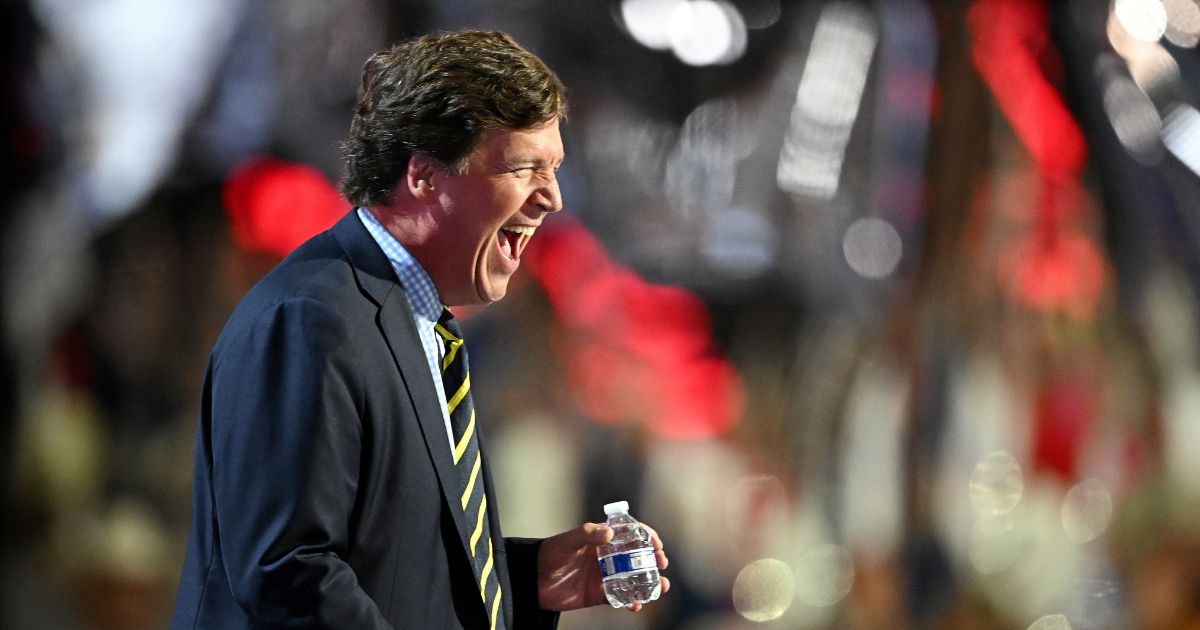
524,216 -> 742,438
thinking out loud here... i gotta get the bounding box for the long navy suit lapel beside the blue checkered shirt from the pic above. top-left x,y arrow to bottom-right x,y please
332,210 -> 477,559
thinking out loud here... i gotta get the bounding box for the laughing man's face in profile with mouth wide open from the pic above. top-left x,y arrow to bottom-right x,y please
422,119 -> 563,305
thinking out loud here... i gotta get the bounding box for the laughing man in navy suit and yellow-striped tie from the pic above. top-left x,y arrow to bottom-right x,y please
173,31 -> 668,630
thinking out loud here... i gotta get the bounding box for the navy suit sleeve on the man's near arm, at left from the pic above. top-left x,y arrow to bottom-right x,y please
211,299 -> 389,629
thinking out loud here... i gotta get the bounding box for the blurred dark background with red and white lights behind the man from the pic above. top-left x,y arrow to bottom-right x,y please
7,0 -> 1200,630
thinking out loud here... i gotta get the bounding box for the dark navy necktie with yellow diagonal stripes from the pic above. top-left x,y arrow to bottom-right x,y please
434,308 -> 504,630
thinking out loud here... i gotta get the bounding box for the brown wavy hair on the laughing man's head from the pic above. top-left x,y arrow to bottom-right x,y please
340,31 -> 566,206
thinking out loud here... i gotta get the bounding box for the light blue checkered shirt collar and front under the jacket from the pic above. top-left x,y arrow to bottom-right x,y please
359,208 -> 454,452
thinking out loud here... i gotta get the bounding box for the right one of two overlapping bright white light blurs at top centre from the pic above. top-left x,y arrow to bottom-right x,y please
667,0 -> 746,66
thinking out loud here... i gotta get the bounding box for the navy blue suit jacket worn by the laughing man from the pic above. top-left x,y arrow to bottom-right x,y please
172,211 -> 557,630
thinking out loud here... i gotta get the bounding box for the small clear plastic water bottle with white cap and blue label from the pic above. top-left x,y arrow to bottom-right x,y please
596,500 -> 662,608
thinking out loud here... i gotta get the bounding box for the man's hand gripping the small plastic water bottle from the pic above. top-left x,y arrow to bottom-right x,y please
538,523 -> 671,612
